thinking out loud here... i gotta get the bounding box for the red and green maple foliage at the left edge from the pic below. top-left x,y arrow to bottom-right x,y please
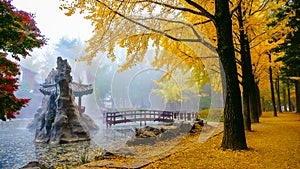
0,0 -> 46,120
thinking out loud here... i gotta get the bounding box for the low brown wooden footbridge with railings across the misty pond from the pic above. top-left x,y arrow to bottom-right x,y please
104,110 -> 197,126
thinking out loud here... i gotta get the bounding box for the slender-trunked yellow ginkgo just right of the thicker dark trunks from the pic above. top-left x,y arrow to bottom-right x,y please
245,0 -> 294,116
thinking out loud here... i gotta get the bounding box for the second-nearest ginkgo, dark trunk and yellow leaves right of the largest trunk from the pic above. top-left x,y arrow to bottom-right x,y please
233,0 -> 291,130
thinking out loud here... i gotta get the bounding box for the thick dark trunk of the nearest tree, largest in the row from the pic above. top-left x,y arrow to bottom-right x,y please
215,0 -> 247,150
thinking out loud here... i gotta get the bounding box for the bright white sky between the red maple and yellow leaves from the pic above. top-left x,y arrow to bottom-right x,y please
12,0 -> 93,44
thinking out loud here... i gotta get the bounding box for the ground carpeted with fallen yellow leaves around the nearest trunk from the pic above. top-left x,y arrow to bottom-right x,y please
79,112 -> 300,169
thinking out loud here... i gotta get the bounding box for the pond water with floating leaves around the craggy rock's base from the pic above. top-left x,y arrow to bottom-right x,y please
0,119 -> 166,169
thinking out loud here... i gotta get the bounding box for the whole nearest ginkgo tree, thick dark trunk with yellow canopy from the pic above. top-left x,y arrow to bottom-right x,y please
61,0 -> 247,150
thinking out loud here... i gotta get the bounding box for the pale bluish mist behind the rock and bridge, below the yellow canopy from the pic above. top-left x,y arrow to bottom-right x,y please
16,38 -> 223,121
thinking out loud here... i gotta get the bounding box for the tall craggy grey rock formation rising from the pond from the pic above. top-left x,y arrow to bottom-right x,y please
32,57 -> 94,144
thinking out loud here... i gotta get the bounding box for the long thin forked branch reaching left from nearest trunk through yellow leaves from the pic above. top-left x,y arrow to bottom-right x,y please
96,0 -> 215,51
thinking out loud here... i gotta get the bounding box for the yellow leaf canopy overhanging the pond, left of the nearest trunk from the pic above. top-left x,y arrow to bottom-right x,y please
61,0 -> 221,90
